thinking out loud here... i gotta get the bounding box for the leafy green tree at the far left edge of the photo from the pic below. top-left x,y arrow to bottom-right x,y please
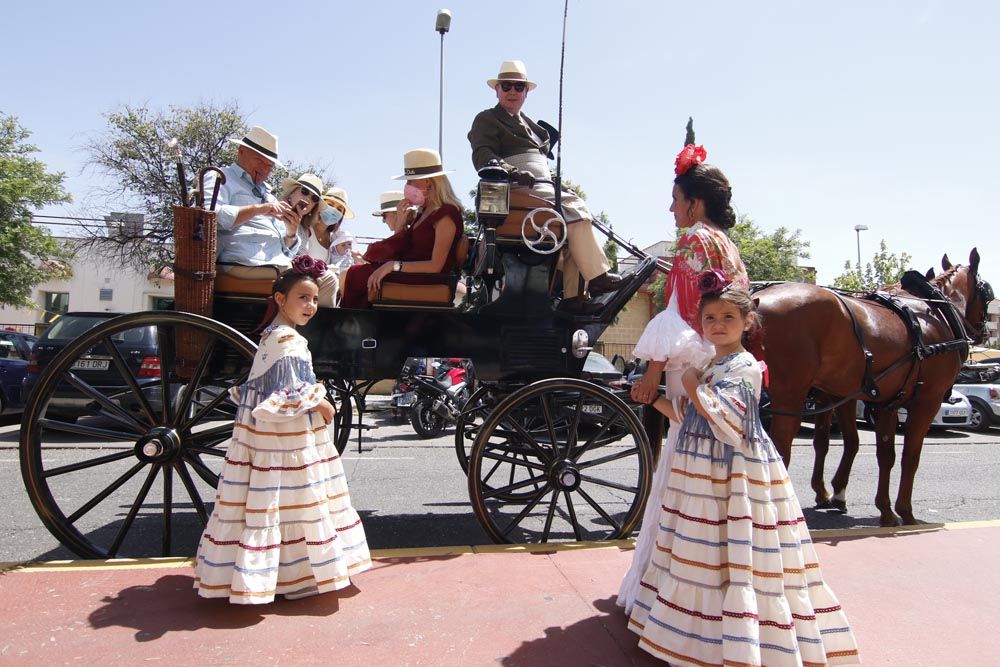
0,112 -> 72,308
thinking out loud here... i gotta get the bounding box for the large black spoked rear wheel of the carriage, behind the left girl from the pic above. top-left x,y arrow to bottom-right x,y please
20,311 -> 256,558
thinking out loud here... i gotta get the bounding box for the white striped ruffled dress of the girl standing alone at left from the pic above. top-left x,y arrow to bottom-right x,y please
194,325 -> 371,604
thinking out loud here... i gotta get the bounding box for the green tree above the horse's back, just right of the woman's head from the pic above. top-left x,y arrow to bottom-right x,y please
729,214 -> 809,281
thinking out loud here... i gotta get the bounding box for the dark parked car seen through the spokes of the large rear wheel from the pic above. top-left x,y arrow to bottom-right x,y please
23,312 -> 160,421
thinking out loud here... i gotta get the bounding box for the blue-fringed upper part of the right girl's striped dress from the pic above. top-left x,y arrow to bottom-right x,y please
697,354 -> 761,449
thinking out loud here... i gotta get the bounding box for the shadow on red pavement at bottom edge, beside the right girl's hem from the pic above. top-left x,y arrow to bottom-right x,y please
499,596 -> 664,667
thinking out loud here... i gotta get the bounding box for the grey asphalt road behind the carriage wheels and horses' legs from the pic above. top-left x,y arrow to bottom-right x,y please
0,404 -> 1000,562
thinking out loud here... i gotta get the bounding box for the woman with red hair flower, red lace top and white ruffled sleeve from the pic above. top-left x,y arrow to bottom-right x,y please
618,144 -> 750,614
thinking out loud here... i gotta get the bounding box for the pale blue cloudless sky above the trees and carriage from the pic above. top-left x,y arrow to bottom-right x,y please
0,0 -> 1000,284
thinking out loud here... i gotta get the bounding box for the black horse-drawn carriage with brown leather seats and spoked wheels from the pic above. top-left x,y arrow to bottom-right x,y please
20,171 -> 658,558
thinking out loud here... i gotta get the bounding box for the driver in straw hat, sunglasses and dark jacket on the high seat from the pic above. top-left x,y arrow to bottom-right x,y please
469,60 -> 622,306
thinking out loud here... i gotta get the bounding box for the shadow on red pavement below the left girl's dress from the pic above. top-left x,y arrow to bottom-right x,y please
87,574 -> 359,642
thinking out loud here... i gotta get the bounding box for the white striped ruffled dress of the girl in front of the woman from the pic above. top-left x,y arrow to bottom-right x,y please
629,351 -> 860,667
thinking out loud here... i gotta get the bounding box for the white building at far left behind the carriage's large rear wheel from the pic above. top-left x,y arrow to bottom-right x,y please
0,239 -> 174,332
